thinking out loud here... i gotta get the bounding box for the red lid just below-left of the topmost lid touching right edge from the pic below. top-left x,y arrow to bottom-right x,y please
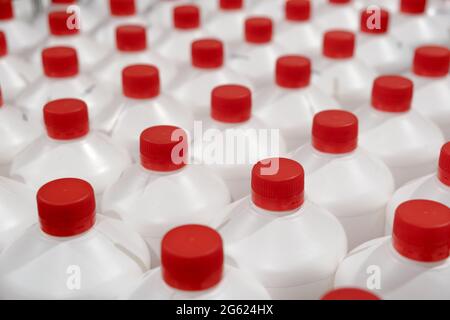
372,76 -> 414,112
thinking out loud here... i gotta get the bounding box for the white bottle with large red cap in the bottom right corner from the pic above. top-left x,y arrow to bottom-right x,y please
335,200 -> 450,300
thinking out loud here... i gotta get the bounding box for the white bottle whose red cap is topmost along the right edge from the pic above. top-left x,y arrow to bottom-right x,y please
411,46 -> 450,140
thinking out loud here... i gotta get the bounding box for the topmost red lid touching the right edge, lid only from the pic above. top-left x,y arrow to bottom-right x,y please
413,46 -> 450,78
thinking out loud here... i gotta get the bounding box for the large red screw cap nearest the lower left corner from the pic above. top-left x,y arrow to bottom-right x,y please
37,178 -> 95,237
